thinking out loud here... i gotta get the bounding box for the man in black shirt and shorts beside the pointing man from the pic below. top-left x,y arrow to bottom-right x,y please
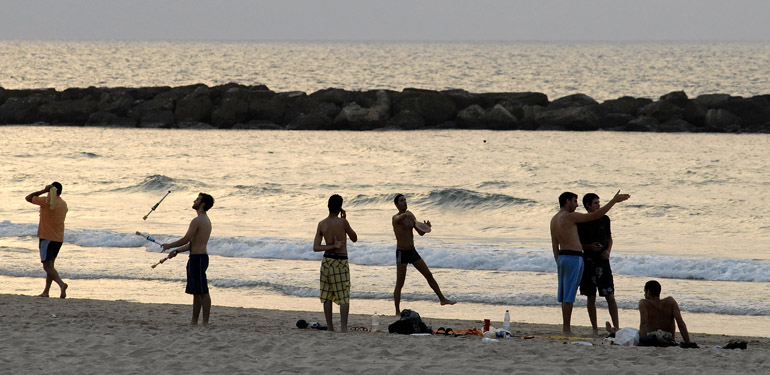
577,193 -> 620,334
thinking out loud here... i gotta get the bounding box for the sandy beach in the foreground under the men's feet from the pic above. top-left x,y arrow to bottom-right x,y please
0,294 -> 770,374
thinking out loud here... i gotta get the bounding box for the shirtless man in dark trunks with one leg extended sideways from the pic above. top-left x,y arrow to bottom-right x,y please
393,194 -> 457,316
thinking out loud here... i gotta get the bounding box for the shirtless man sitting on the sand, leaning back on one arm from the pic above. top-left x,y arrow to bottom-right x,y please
639,280 -> 690,345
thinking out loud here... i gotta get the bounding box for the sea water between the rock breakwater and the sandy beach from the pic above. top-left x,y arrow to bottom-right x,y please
0,126 -> 770,336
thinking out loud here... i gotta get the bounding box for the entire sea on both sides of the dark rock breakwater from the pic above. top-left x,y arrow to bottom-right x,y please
0,41 -> 770,337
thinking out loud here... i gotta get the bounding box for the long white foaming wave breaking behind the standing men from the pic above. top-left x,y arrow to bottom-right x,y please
0,220 -> 770,282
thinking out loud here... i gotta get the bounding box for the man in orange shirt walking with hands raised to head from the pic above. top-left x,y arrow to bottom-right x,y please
25,182 -> 68,298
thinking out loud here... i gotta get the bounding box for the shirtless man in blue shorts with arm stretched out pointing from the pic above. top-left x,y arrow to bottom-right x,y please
551,190 -> 631,336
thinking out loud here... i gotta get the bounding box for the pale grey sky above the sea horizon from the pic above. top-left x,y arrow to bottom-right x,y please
0,0 -> 770,41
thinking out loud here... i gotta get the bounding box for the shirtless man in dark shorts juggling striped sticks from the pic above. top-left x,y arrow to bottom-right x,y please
161,193 -> 214,326
